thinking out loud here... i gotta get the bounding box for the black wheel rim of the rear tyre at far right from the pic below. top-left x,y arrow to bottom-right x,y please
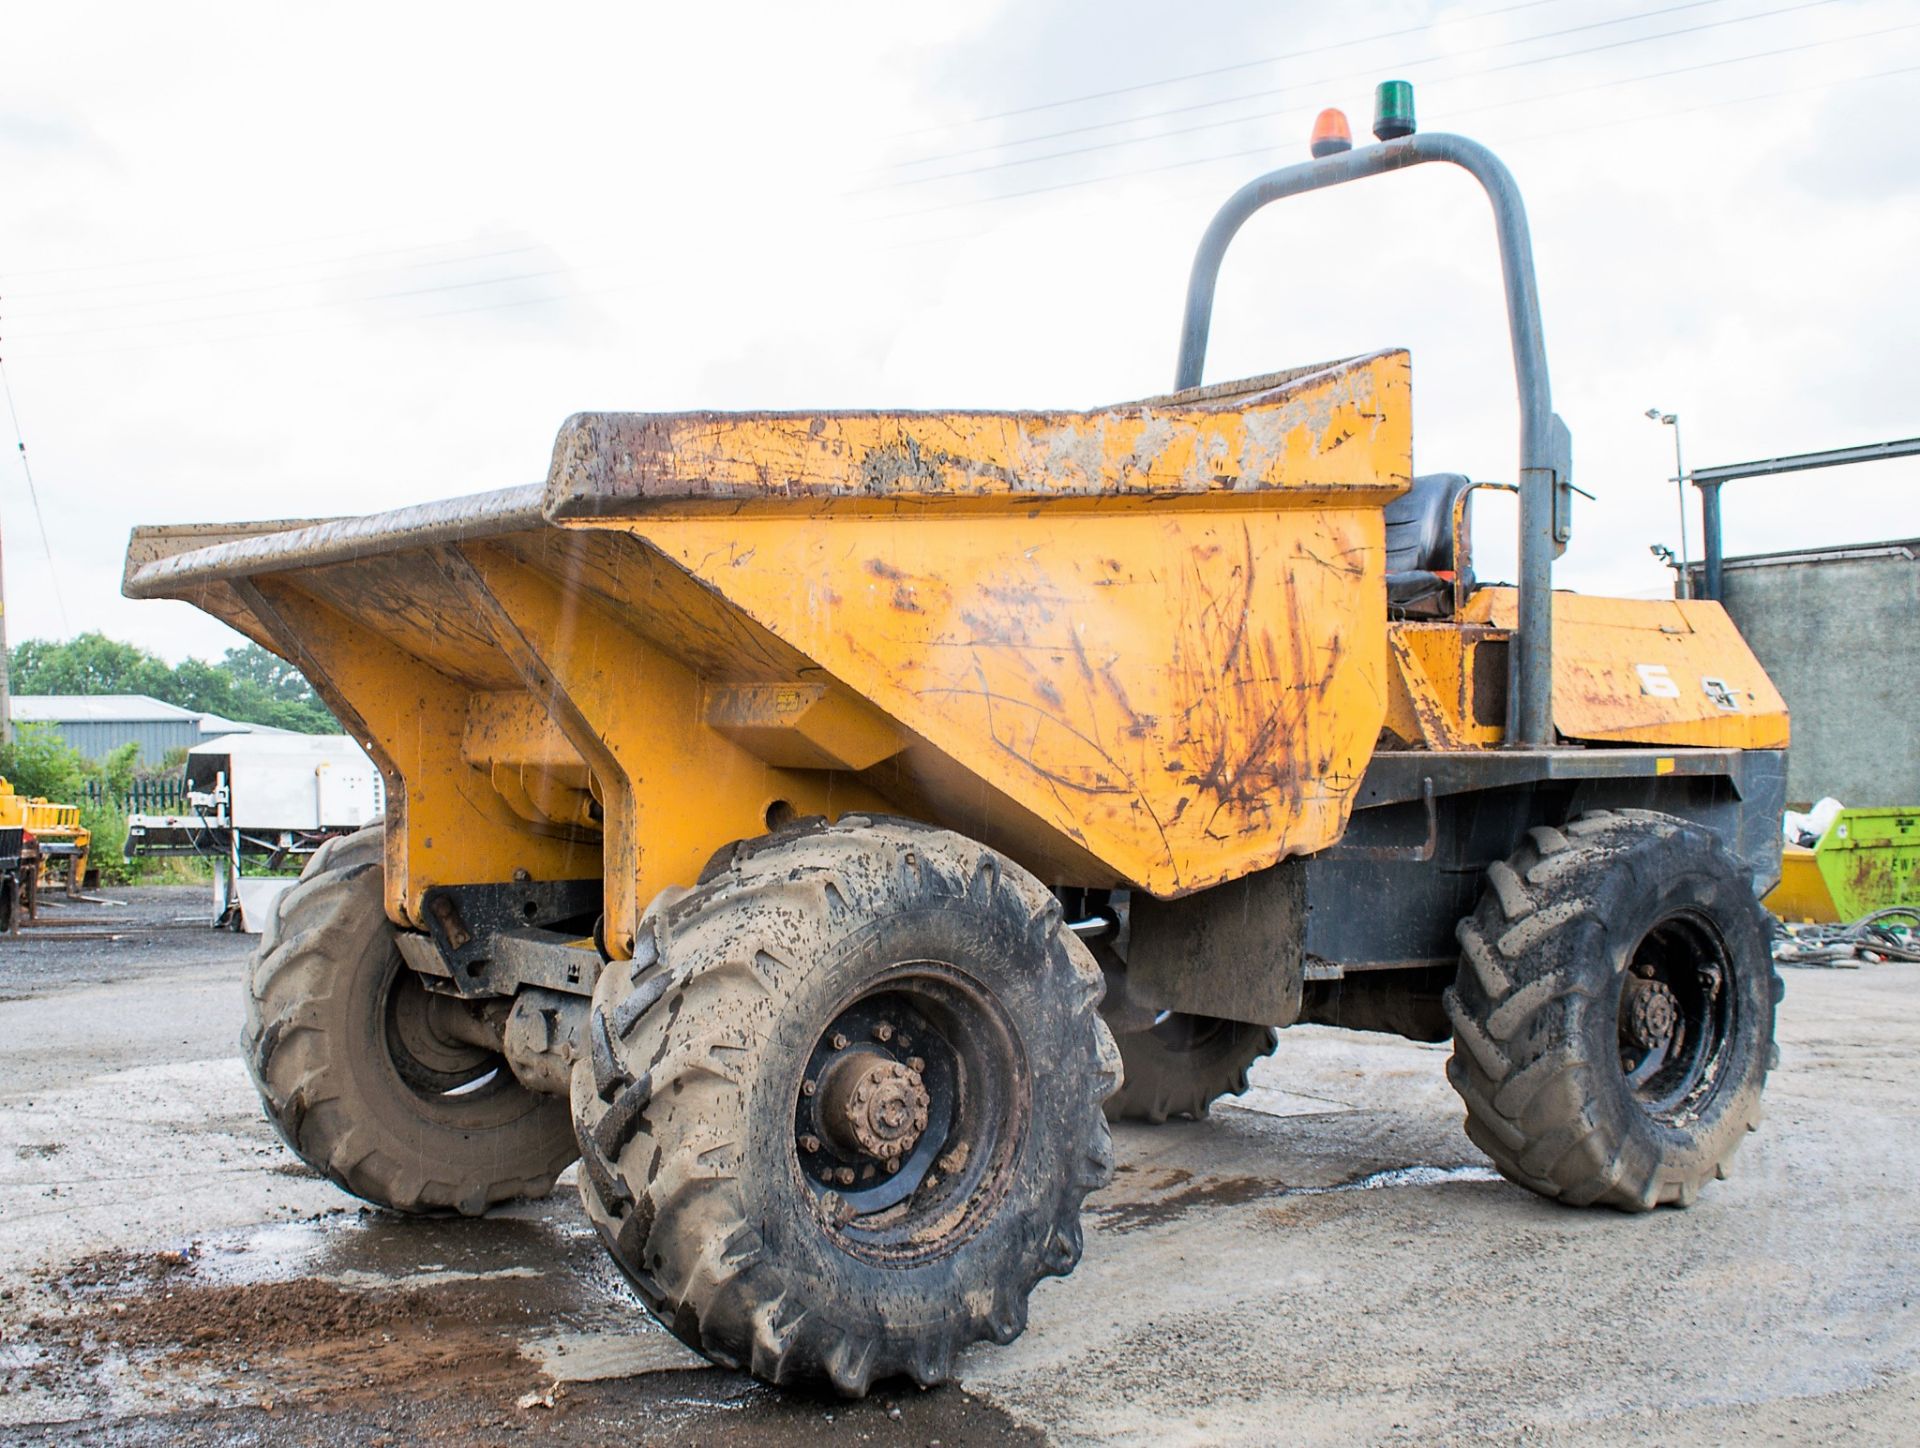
1615,910 -> 1734,1125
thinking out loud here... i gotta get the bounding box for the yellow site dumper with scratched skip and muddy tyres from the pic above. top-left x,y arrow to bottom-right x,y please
125,118 -> 1788,1394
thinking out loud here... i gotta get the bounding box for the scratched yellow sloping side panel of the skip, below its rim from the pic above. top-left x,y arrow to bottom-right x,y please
630,507 -> 1386,895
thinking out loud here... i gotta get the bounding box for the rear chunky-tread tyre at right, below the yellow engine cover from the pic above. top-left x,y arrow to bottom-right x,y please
1446,810 -> 1782,1212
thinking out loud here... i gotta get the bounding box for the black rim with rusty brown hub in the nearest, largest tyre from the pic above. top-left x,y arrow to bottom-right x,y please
793,960 -> 1031,1266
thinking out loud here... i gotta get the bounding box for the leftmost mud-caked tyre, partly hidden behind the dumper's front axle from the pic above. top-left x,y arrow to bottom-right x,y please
240,826 -> 576,1216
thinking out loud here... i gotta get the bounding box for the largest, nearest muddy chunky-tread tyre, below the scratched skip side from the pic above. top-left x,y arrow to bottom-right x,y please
574,816 -> 1117,1396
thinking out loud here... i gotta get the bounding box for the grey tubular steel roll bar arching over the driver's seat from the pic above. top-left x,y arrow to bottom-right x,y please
1173,133 -> 1572,747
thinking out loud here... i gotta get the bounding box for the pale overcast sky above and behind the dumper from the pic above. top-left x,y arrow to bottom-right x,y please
0,0 -> 1920,659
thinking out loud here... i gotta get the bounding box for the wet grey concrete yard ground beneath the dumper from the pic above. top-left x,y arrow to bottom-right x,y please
0,889 -> 1920,1444
